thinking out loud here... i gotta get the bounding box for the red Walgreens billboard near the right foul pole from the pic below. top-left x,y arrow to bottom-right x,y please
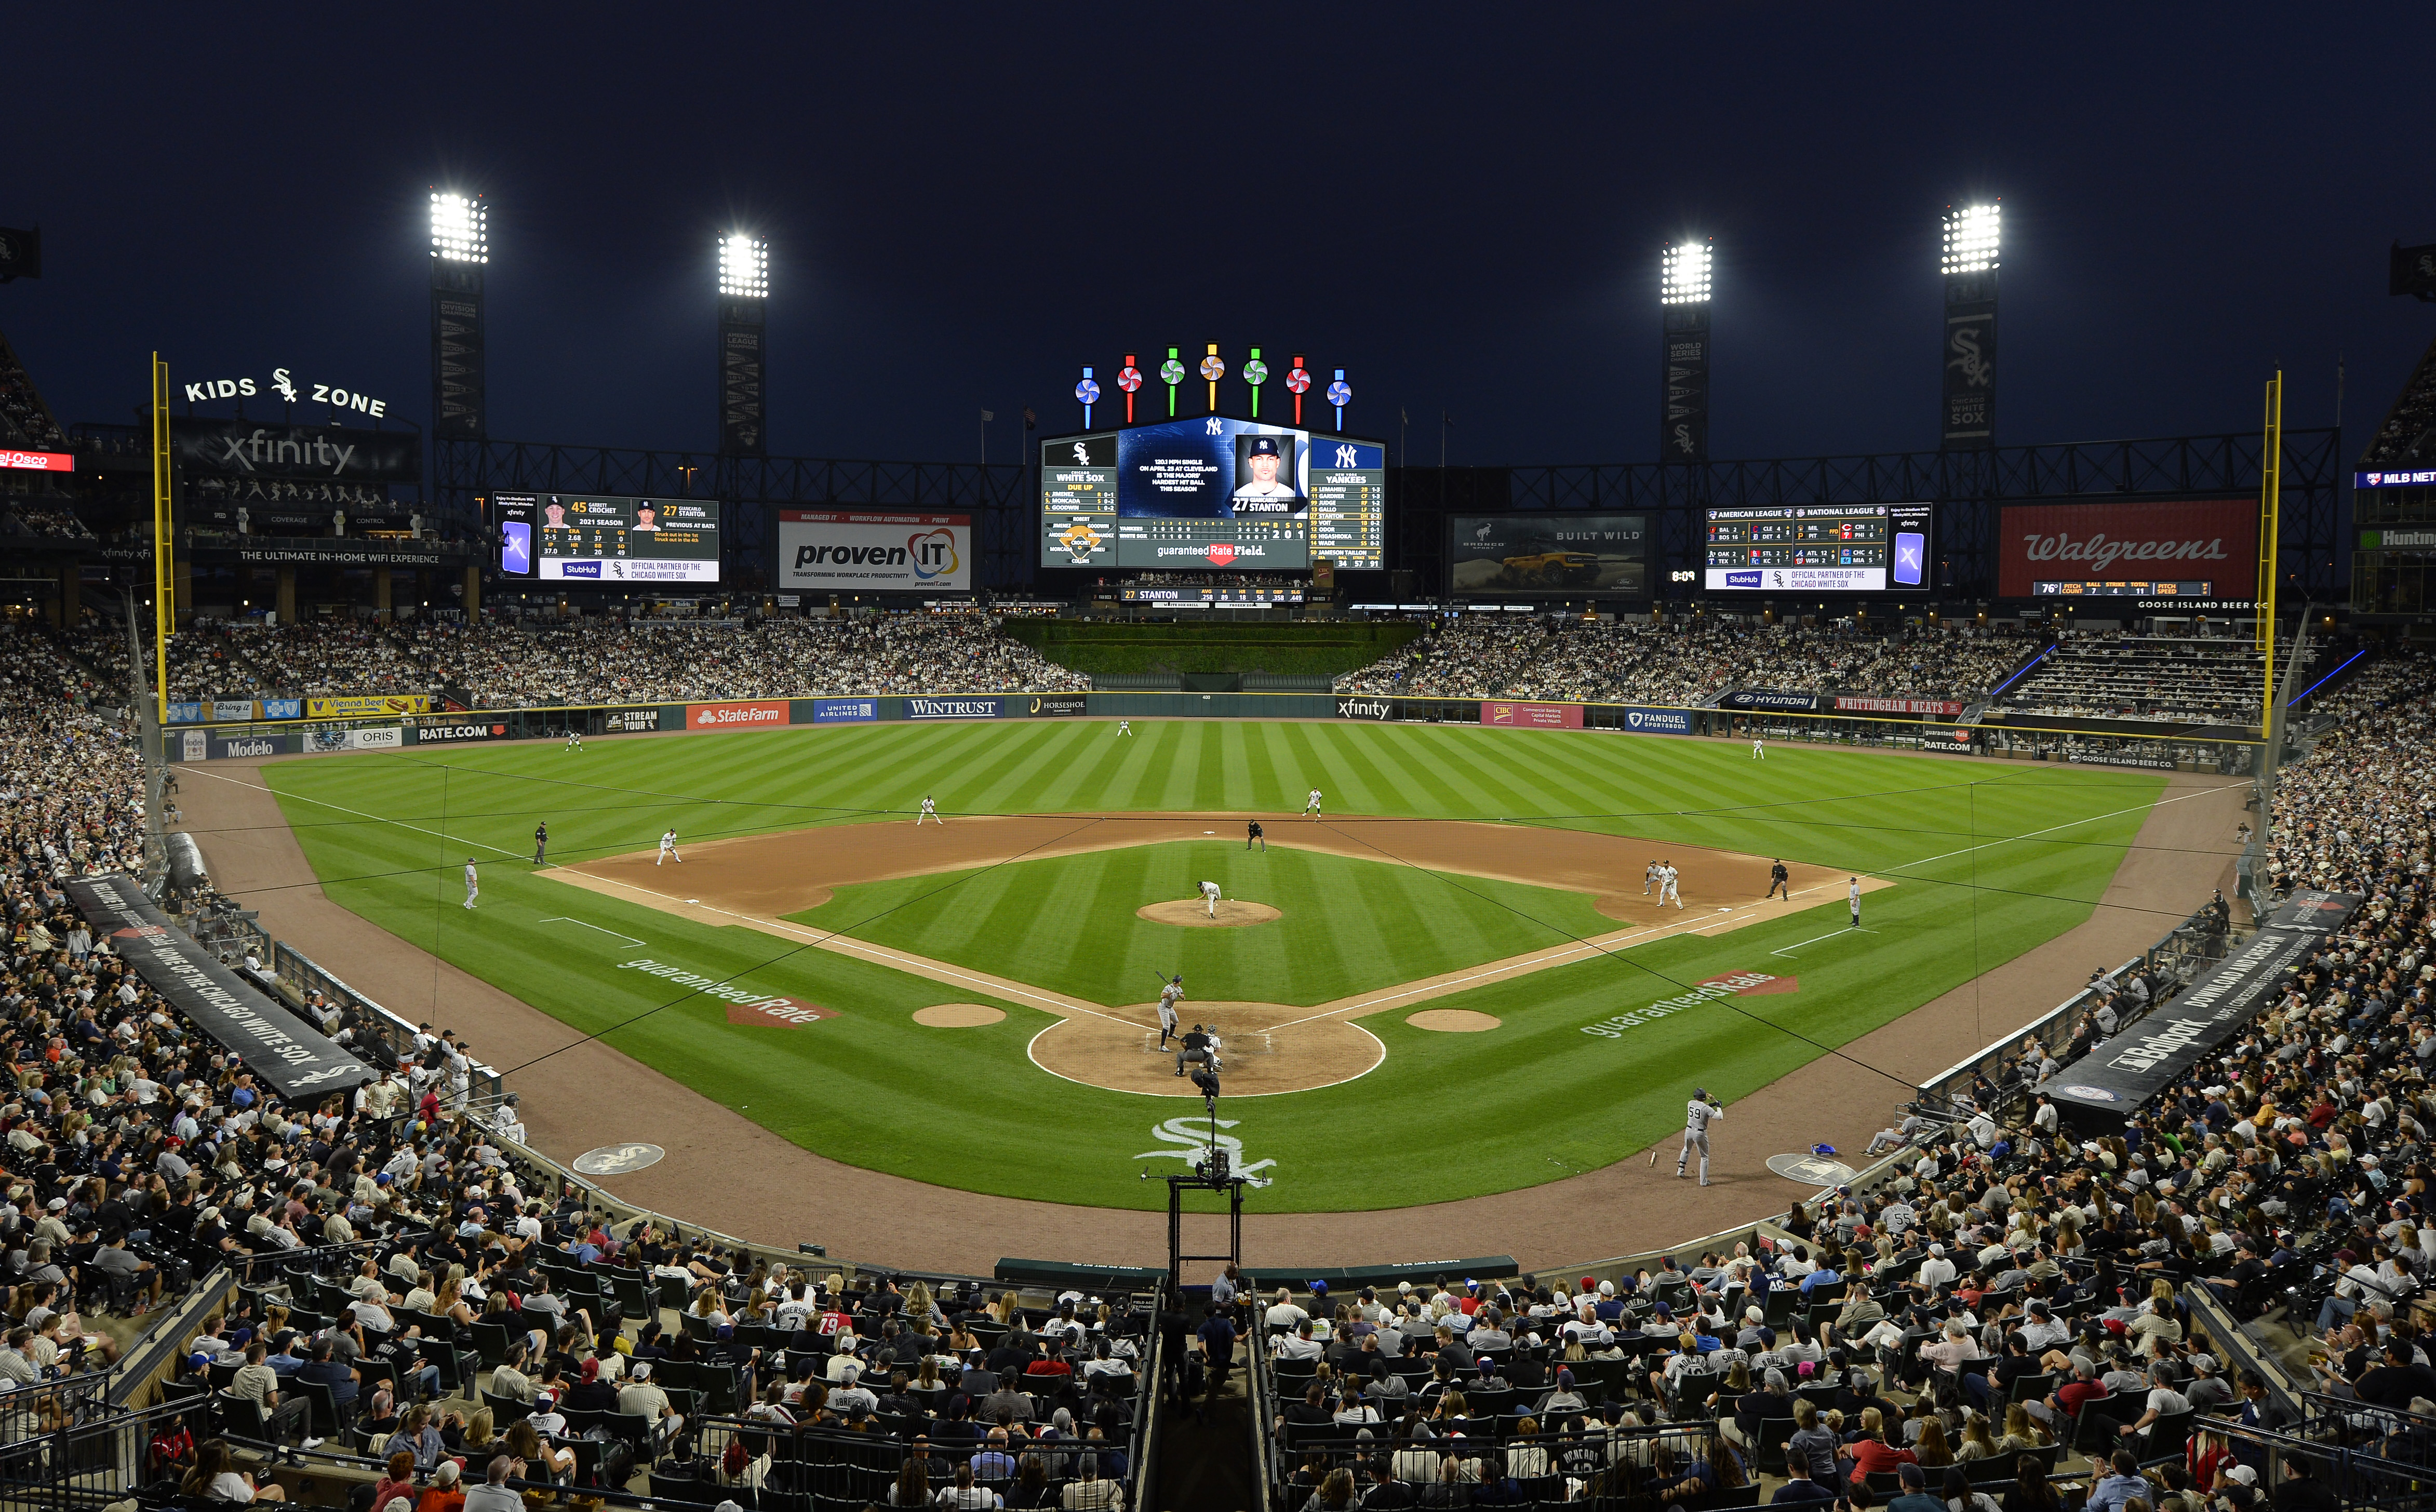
1998,499 -> 2258,599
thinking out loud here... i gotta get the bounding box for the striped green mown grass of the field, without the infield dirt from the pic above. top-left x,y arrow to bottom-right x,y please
265,721 -> 2171,1210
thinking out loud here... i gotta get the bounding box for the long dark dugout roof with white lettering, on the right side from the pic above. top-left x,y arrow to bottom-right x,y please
2044,891 -> 2361,1132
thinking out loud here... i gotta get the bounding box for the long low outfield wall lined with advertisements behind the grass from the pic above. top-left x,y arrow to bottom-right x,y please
161,691 -> 2258,774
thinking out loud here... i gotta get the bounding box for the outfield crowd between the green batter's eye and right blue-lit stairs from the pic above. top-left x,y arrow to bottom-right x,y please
1337,616 -> 2037,706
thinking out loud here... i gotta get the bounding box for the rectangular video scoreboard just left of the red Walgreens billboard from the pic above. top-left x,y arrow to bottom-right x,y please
1703,504 -> 1937,594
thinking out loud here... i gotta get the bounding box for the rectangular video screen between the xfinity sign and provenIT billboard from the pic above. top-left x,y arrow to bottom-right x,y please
492,494 -> 719,582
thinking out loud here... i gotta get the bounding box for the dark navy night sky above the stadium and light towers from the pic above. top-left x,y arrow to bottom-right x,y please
0,5 -> 2436,463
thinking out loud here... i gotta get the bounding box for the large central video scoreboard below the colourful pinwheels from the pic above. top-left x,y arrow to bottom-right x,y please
1040,414 -> 1386,572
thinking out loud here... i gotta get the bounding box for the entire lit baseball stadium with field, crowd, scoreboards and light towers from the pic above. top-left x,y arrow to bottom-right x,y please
0,32 -> 2436,1512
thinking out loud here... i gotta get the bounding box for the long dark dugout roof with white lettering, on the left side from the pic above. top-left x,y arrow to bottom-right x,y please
68,877 -> 373,1098
